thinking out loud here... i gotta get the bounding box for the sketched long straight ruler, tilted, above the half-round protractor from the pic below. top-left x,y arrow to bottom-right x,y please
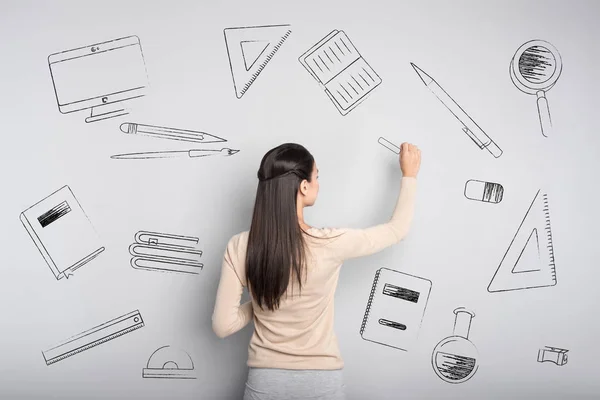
42,310 -> 144,365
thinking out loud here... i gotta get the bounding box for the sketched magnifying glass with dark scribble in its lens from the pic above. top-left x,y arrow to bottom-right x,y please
509,40 -> 562,137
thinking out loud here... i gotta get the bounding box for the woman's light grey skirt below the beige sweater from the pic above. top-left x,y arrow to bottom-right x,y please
243,367 -> 346,400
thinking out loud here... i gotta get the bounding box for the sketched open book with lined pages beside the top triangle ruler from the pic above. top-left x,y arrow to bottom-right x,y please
298,29 -> 382,115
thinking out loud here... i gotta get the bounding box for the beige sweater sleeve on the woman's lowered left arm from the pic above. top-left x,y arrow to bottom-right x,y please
212,236 -> 254,339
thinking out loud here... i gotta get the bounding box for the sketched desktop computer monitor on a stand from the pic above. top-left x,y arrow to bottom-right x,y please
48,36 -> 148,122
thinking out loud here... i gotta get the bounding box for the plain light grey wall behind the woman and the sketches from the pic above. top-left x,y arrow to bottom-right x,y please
0,0 -> 600,399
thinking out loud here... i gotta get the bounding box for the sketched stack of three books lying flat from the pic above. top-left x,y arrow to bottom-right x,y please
129,231 -> 204,274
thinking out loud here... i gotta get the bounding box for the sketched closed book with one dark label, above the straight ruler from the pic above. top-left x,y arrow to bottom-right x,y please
20,186 -> 104,280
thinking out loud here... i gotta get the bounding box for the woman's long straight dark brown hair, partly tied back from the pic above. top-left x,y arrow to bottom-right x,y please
246,143 -> 314,311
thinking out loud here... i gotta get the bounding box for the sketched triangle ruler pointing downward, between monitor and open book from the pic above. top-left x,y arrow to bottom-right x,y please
223,25 -> 292,99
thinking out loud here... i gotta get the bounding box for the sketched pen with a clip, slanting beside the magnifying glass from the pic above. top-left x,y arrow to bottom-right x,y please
410,63 -> 502,158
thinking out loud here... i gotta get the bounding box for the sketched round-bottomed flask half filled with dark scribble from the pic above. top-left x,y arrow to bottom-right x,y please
431,307 -> 479,383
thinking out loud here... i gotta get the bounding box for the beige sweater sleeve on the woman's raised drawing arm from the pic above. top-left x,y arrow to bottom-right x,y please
329,177 -> 417,261
